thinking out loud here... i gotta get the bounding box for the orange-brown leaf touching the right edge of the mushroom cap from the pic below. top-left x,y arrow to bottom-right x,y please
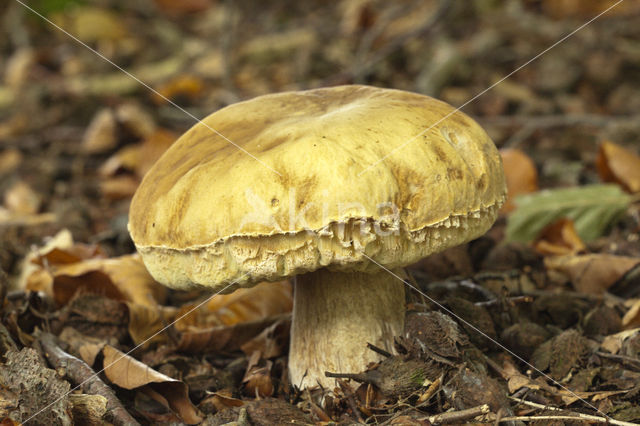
500,148 -> 538,213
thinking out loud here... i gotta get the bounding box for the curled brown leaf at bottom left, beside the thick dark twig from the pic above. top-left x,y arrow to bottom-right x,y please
102,345 -> 202,424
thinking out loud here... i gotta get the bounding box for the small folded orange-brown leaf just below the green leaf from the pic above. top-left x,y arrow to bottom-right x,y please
533,218 -> 587,256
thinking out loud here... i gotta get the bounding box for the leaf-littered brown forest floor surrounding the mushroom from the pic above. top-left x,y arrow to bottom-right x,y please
0,0 -> 640,425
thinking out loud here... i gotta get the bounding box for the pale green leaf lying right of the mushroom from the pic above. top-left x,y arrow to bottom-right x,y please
507,185 -> 632,242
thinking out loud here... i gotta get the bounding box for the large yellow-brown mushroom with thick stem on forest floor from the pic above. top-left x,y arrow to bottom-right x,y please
129,85 -> 505,388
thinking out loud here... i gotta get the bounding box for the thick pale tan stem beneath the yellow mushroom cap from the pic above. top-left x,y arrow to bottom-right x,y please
289,269 -> 406,389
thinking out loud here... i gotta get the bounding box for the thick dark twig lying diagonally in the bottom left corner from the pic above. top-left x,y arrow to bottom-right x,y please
38,333 -> 139,425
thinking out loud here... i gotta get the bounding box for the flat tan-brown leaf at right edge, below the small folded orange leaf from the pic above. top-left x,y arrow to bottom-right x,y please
544,253 -> 640,294
